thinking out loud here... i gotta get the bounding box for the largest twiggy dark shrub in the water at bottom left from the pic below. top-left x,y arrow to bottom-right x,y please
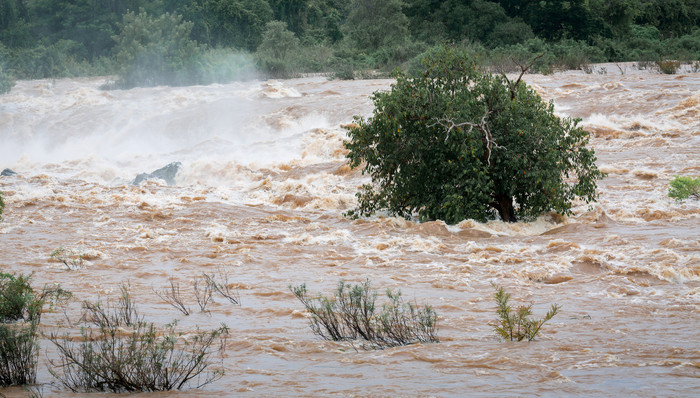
48,286 -> 228,392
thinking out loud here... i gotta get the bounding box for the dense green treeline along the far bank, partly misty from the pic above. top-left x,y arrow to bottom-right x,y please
0,0 -> 700,92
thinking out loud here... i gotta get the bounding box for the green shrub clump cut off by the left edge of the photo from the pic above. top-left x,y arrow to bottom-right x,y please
0,273 -> 70,386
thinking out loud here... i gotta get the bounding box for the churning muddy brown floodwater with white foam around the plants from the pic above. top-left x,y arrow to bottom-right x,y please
0,65 -> 700,397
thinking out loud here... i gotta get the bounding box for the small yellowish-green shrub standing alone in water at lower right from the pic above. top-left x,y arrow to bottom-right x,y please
494,287 -> 561,341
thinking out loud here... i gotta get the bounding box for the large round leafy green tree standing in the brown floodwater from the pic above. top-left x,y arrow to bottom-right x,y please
345,47 -> 603,223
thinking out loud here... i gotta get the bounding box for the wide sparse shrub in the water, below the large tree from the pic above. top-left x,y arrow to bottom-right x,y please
290,280 -> 440,348
